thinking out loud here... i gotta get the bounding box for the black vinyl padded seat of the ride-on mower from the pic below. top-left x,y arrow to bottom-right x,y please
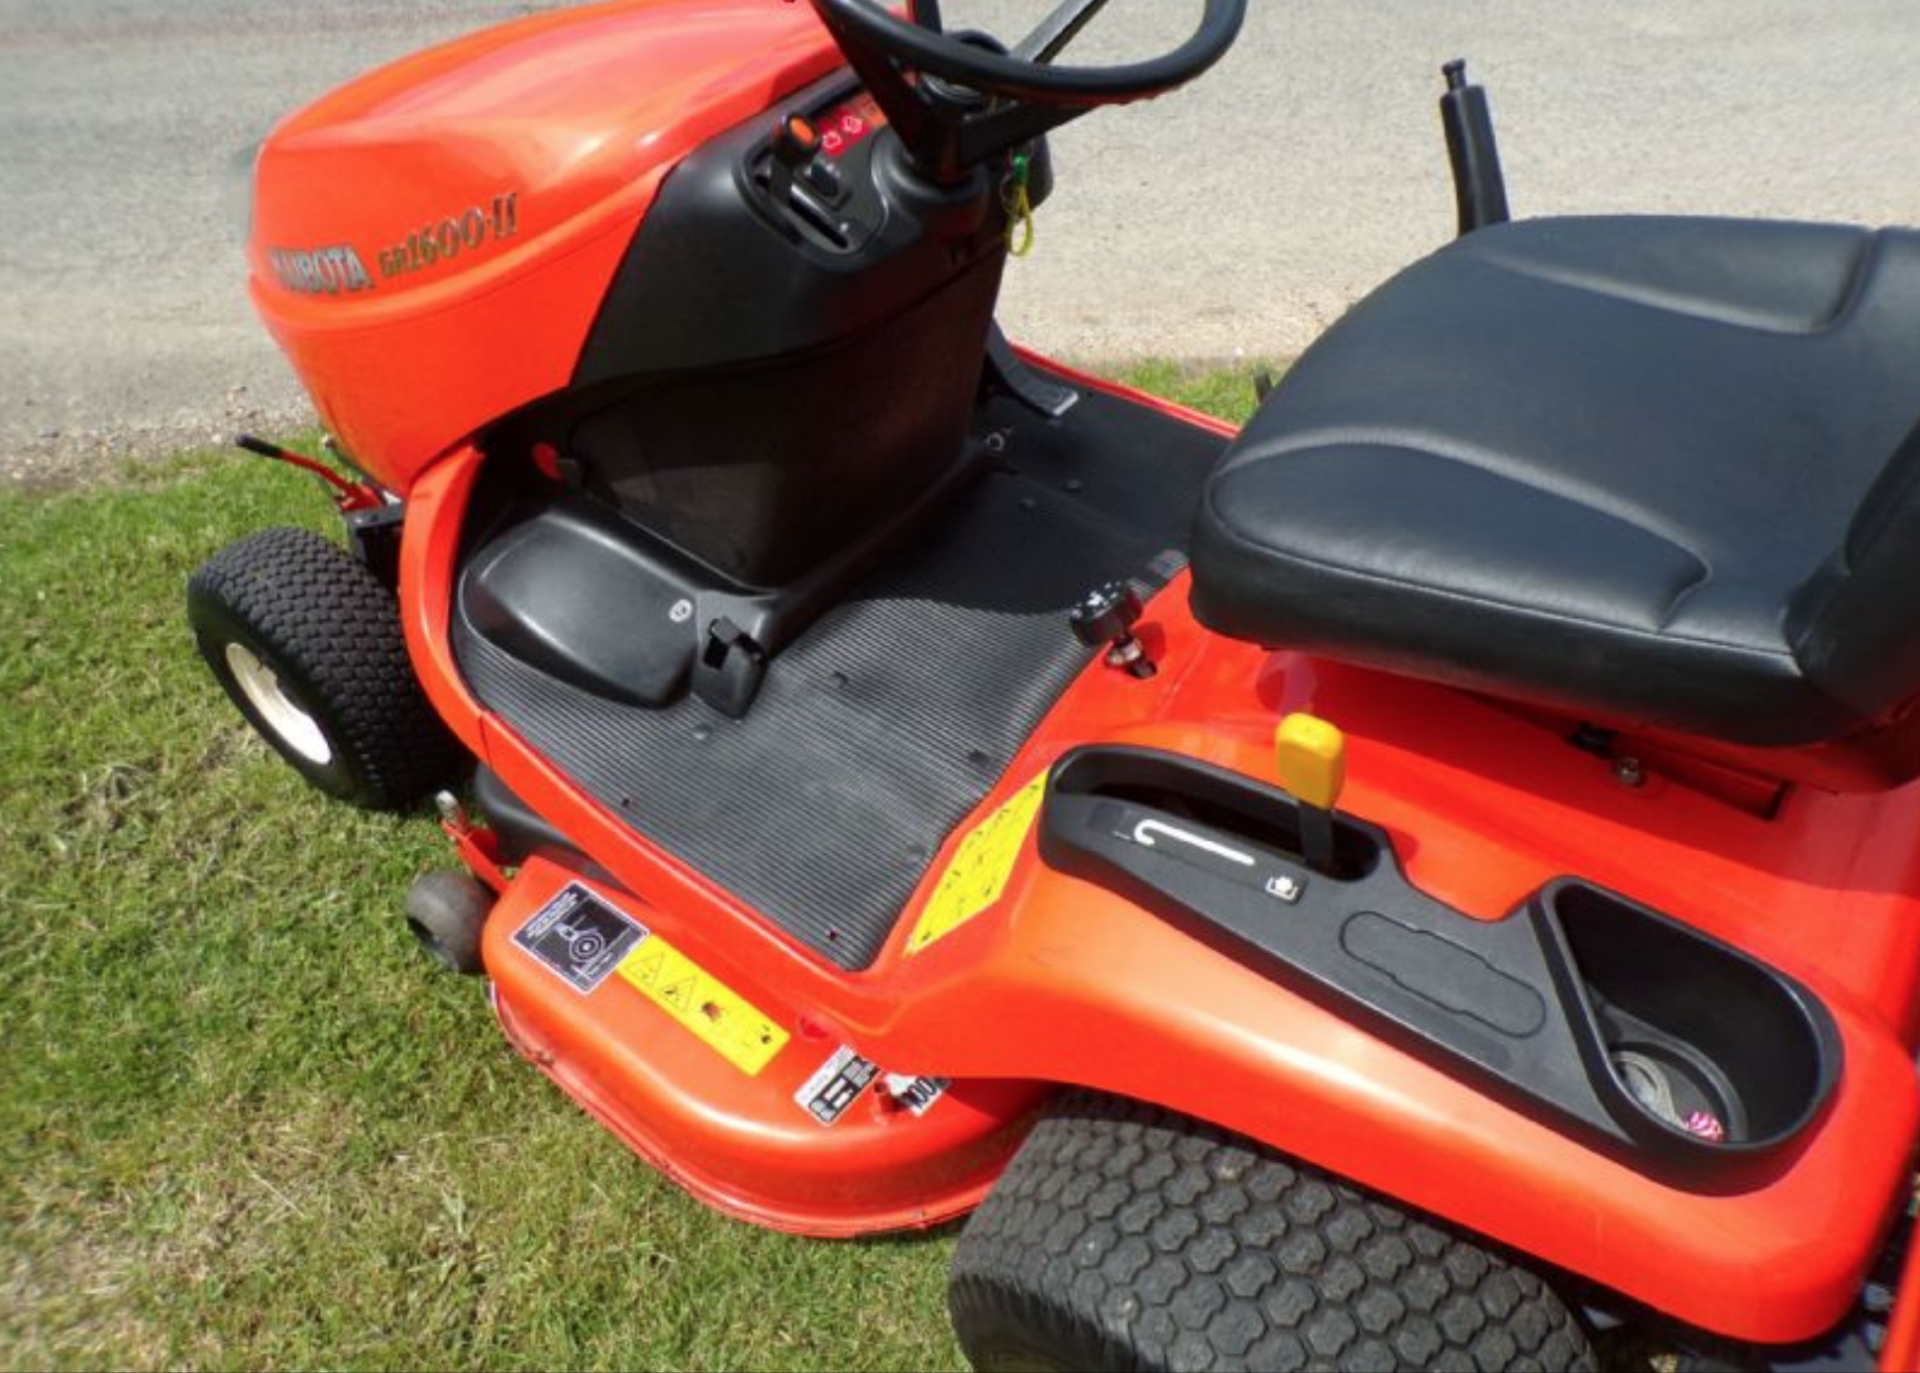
1192,217 -> 1920,785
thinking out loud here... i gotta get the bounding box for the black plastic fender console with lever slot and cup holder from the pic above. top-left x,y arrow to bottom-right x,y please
1041,749 -> 1841,1187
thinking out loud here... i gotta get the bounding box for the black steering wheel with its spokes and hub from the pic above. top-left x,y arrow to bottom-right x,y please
812,0 -> 1246,182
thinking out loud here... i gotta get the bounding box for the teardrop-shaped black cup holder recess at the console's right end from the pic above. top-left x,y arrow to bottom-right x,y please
1536,879 -> 1839,1158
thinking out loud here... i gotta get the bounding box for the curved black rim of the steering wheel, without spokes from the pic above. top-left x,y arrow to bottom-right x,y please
812,0 -> 1246,109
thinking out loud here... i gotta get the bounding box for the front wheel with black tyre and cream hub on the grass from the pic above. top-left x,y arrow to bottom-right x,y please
186,530 -> 465,810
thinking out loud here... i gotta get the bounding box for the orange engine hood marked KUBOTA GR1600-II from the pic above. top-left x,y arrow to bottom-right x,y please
248,0 -> 841,495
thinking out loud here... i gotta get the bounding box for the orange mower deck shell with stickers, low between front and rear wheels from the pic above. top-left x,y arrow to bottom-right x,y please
486,858 -> 1048,1237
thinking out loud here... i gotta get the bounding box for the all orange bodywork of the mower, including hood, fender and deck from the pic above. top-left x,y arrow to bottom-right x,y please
250,0 -> 1920,1358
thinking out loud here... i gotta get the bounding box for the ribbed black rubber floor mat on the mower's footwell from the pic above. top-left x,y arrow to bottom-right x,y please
453,382 -> 1223,970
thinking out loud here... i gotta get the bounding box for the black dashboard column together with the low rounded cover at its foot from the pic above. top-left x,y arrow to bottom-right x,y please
461,73 -> 1036,718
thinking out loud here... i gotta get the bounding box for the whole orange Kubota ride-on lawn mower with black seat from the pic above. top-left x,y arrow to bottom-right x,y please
190,0 -> 1920,1369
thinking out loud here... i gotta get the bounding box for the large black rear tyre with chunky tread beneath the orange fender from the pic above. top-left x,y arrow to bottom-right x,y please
948,1093 -> 1596,1373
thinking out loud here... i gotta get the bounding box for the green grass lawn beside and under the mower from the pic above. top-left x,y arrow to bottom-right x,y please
0,365 -> 1274,1369
